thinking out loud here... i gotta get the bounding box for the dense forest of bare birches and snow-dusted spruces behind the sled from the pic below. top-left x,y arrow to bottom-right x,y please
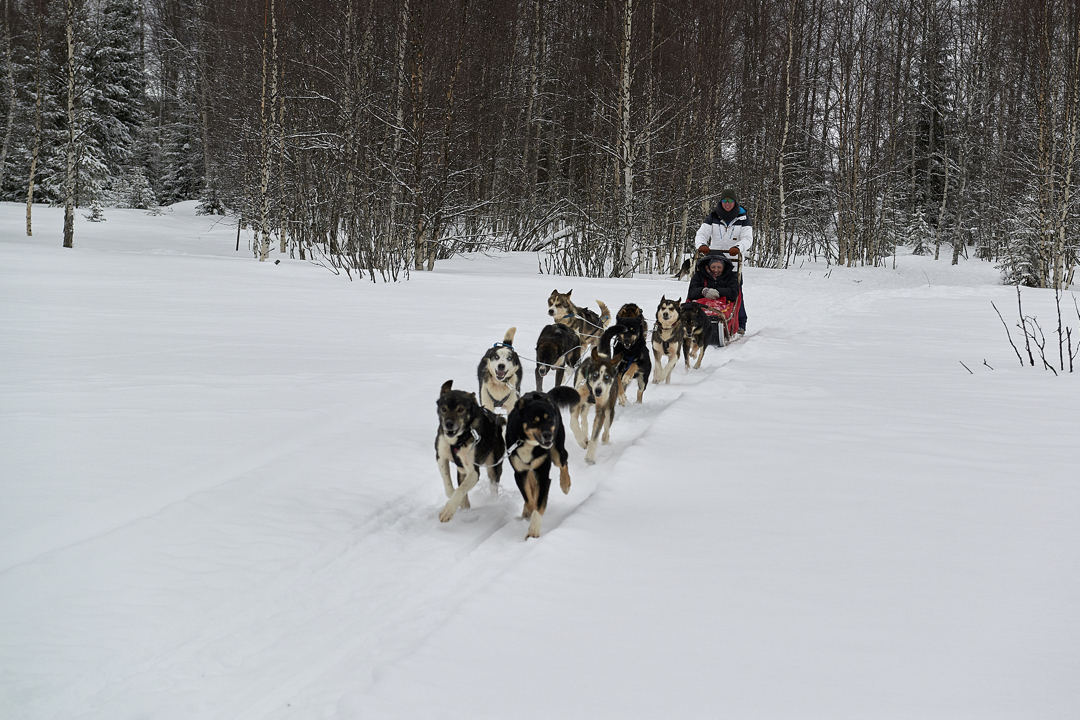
0,0 -> 1080,289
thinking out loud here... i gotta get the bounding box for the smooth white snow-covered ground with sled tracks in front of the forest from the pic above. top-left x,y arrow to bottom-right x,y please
0,203 -> 1080,720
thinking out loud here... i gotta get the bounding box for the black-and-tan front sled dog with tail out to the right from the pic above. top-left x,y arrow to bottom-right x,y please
507,386 -> 579,538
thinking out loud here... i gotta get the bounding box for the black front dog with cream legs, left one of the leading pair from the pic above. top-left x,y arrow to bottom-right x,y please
435,380 -> 507,522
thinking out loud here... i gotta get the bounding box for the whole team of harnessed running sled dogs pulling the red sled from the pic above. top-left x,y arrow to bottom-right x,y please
435,289 -> 711,538
